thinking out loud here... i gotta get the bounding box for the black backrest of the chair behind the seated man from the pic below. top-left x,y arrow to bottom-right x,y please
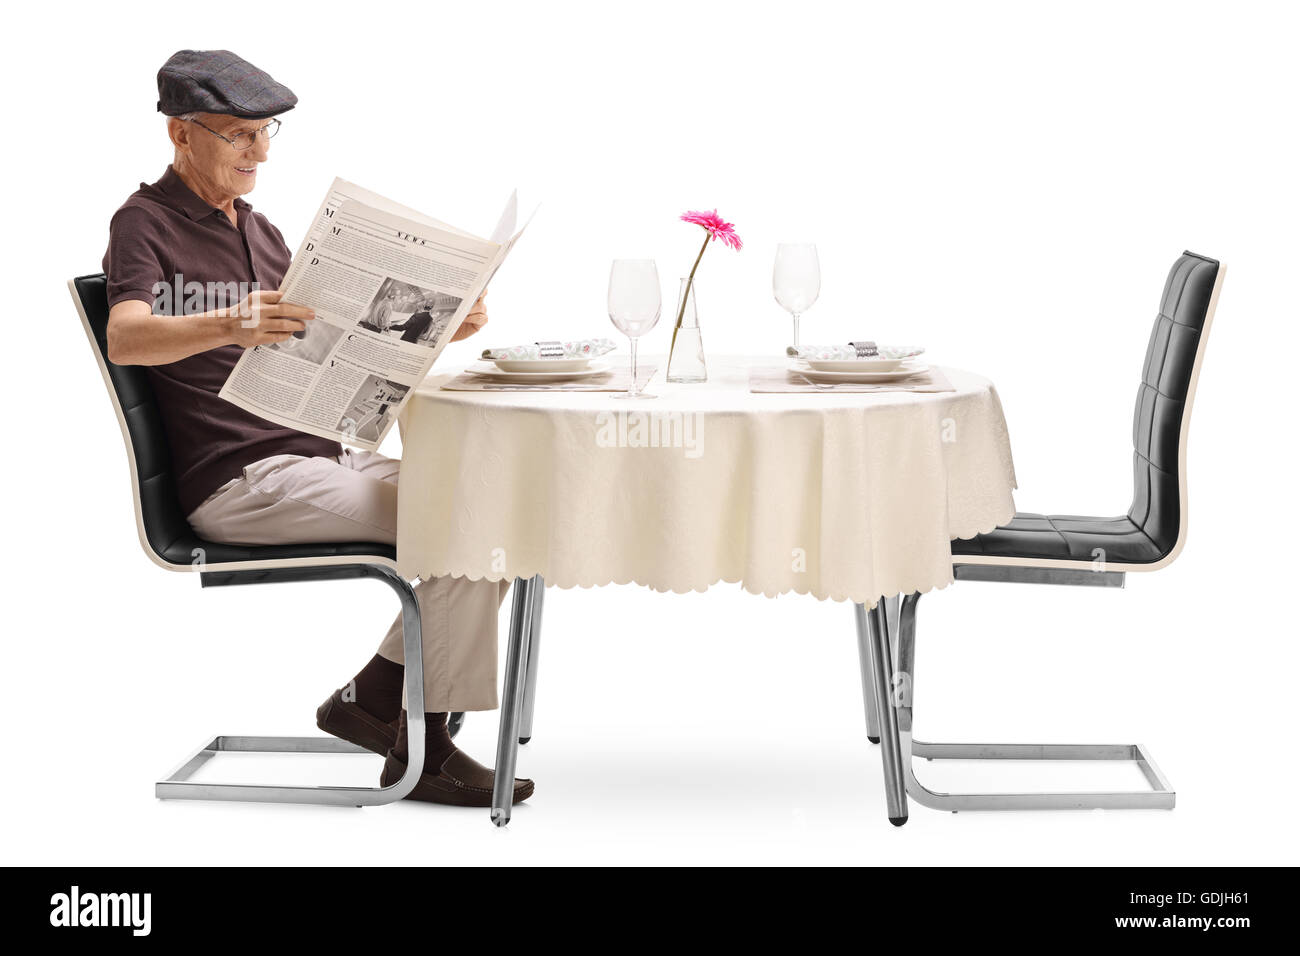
69,273 -> 198,570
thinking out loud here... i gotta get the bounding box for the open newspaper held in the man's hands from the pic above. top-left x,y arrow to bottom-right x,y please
221,179 -> 527,451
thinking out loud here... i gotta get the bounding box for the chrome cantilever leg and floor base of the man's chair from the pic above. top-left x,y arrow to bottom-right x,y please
153,564 -> 425,806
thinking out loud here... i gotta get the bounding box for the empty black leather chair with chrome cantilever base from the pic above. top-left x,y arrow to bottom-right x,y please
858,252 -> 1225,825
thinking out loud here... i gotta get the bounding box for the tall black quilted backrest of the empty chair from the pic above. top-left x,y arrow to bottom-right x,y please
1128,252 -> 1223,564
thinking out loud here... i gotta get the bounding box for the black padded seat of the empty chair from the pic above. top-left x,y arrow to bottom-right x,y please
953,511 -> 1165,564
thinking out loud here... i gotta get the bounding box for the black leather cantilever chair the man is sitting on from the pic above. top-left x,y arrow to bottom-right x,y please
68,274 -> 444,806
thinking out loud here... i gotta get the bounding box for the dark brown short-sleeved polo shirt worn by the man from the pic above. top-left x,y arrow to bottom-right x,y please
104,166 -> 342,514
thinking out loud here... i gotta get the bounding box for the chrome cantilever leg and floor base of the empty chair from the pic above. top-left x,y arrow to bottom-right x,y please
898,594 -> 1175,813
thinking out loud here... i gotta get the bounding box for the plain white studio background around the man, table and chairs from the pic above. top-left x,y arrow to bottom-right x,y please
0,0 -> 1300,865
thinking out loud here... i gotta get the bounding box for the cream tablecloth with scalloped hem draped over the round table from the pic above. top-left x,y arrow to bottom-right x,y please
398,356 -> 1015,605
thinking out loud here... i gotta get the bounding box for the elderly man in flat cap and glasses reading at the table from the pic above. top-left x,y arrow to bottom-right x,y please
104,49 -> 533,806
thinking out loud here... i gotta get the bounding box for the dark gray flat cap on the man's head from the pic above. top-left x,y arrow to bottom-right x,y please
159,49 -> 298,120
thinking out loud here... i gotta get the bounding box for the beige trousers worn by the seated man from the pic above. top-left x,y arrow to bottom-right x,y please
190,450 -> 510,713
